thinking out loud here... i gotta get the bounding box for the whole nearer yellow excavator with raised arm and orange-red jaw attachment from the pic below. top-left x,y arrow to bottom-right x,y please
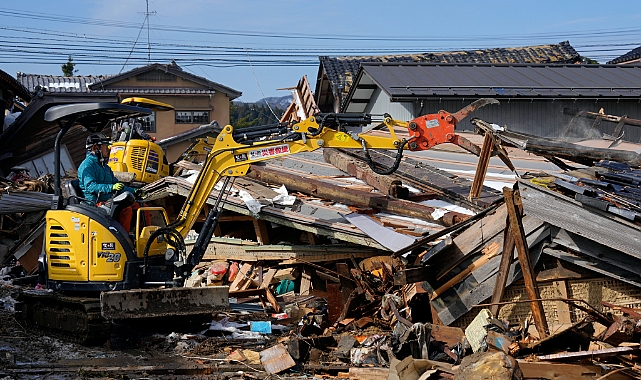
16,99 -> 496,342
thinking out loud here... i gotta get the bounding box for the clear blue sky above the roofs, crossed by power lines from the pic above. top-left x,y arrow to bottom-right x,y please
0,0 -> 641,102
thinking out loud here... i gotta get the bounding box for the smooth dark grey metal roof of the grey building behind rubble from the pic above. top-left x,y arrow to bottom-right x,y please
348,63 -> 641,101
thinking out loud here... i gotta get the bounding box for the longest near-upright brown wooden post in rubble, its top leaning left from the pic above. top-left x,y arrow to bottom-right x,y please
503,187 -> 548,339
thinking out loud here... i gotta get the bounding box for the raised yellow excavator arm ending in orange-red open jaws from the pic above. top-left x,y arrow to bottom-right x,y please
172,99 -> 498,237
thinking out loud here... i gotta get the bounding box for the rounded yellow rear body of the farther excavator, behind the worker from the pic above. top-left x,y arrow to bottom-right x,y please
109,140 -> 169,183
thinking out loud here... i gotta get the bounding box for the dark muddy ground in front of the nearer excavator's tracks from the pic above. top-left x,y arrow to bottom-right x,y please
0,283 -> 309,379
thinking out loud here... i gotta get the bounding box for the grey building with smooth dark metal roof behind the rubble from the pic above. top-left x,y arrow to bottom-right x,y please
341,62 -> 641,142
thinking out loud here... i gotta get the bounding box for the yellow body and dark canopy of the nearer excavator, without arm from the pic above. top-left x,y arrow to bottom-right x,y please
44,103 -> 174,292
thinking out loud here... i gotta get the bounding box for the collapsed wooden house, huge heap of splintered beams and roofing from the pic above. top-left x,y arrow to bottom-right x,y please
1,41 -> 641,379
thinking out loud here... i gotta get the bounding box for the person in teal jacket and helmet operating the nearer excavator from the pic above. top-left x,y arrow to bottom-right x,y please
78,133 -> 140,233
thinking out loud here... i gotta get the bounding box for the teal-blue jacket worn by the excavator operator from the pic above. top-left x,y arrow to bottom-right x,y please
78,153 -> 136,204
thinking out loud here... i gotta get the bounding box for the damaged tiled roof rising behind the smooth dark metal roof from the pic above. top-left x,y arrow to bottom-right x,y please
315,41 -> 581,110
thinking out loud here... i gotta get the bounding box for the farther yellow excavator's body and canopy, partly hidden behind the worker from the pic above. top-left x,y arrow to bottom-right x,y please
109,98 -> 174,185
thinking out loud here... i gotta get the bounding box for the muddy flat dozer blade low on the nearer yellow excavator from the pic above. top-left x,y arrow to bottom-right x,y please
100,286 -> 229,320
